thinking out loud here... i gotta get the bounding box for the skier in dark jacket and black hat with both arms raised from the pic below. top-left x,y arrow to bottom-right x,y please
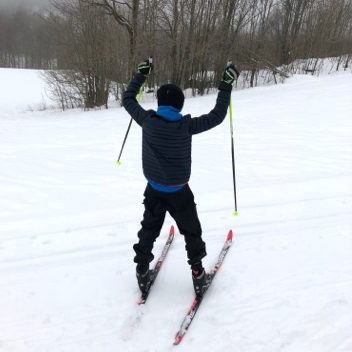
122,59 -> 239,296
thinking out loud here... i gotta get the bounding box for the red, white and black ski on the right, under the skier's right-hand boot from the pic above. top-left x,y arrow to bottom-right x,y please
174,230 -> 233,345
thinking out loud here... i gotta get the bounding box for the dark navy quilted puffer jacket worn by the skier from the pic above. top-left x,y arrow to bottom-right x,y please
122,73 -> 232,186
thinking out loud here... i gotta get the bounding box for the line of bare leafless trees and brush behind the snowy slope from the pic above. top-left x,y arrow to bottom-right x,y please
0,0 -> 352,108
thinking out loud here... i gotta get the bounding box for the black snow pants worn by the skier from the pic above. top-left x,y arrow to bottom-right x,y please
133,184 -> 206,266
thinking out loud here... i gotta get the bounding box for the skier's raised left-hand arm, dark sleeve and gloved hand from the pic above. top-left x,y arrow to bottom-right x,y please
122,59 -> 153,126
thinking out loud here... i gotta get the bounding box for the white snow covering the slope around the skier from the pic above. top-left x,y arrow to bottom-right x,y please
0,69 -> 352,352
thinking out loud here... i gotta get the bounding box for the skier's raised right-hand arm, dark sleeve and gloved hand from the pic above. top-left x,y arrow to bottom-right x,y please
190,62 -> 239,134
